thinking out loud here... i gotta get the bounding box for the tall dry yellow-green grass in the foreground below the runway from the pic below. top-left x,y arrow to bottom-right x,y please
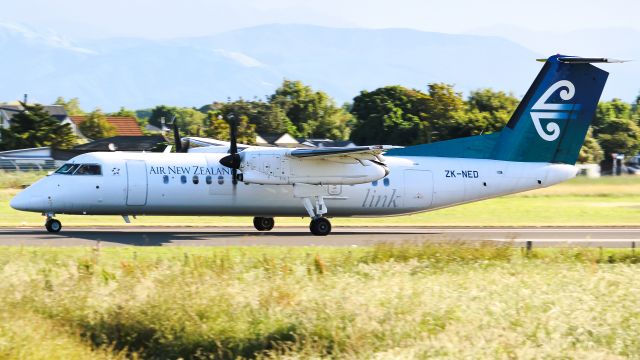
0,244 -> 640,359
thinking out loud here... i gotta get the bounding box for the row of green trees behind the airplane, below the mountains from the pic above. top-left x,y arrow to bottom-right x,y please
0,80 -> 640,163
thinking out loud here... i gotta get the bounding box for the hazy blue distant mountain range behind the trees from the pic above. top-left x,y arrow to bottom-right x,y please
6,25 -> 624,111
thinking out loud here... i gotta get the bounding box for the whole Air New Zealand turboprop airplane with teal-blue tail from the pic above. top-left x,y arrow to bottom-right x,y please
10,55 -> 620,235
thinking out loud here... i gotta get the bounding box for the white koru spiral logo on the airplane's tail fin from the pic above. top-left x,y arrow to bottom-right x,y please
531,80 -> 580,141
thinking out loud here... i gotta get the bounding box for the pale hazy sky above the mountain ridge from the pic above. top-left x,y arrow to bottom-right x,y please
0,0 -> 640,39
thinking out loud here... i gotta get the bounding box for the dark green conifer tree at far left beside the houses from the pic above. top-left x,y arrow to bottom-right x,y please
0,103 -> 78,150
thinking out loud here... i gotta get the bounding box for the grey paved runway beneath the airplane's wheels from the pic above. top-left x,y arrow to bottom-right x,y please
0,226 -> 640,248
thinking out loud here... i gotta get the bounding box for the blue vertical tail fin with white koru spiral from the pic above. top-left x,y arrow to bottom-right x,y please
491,55 -> 617,164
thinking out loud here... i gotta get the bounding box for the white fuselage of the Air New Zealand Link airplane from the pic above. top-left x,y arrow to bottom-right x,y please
11,152 -> 576,217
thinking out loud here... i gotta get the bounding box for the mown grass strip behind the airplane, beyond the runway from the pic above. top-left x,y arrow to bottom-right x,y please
0,173 -> 640,226
